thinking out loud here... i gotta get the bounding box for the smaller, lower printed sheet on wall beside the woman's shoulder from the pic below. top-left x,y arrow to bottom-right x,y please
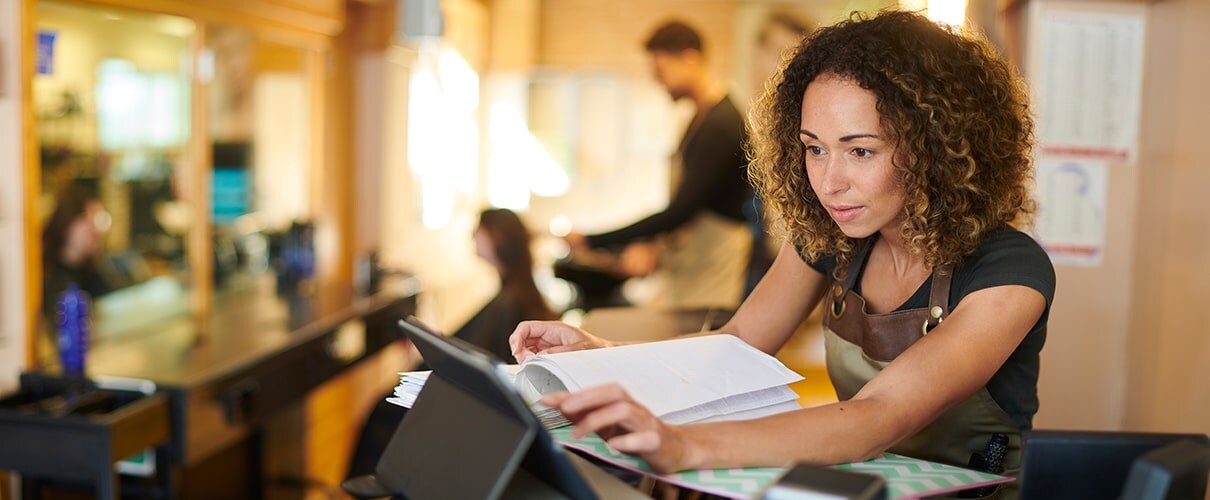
1035,157 -> 1108,266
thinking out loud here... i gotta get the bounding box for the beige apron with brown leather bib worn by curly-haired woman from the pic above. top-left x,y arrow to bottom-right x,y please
823,238 -> 1021,499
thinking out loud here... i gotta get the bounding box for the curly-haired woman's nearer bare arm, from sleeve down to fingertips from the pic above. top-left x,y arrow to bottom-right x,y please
543,280 -> 1045,472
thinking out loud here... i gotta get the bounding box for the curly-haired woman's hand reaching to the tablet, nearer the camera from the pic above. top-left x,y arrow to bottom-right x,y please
542,384 -> 691,473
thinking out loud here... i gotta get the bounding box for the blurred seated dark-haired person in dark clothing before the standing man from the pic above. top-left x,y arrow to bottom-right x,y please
346,208 -> 559,477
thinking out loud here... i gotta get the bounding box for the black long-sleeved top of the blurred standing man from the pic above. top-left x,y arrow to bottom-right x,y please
588,97 -> 751,247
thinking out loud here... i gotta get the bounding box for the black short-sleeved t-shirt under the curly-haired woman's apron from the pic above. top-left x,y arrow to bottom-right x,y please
800,226 -> 1055,430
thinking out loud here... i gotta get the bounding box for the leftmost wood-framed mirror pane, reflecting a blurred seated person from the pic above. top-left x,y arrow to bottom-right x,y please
33,1 -> 195,346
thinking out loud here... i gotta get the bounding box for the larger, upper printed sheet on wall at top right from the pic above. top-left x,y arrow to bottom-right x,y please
1030,2 -> 1146,163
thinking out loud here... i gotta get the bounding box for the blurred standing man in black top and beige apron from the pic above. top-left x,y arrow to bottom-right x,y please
567,21 -> 753,309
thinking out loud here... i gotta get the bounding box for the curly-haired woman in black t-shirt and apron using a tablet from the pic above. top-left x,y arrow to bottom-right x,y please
511,11 -> 1055,493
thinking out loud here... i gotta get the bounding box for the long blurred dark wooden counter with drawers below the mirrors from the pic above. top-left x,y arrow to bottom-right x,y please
27,275 -> 420,465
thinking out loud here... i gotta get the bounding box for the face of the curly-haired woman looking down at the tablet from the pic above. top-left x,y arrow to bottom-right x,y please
799,74 -> 905,238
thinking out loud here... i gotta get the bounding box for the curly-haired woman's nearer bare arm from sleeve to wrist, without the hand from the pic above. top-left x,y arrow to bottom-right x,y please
674,286 -> 1045,469
